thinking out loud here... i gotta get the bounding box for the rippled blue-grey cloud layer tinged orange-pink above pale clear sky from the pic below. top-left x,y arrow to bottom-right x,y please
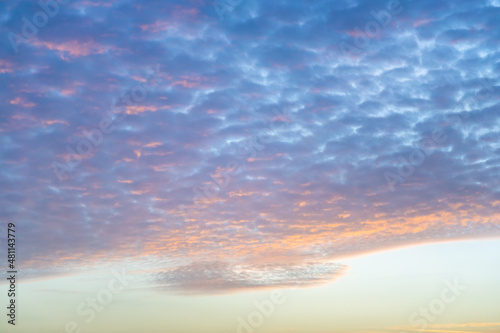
0,0 -> 500,292
